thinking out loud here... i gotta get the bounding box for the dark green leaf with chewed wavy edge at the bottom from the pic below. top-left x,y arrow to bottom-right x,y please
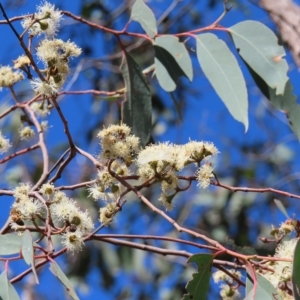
182,254 -> 214,300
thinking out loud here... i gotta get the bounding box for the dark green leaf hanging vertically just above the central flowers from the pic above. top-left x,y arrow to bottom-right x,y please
121,51 -> 152,147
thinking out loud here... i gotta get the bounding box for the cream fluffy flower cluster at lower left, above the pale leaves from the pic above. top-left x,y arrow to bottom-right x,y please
11,183 -> 94,252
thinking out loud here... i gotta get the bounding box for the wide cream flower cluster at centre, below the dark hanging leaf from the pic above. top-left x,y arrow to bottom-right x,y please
136,141 -> 218,210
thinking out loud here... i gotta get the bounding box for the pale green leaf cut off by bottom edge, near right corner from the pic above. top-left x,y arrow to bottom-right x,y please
245,273 -> 282,300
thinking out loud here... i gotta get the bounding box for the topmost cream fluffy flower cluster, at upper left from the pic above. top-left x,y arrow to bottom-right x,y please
21,1 -> 62,38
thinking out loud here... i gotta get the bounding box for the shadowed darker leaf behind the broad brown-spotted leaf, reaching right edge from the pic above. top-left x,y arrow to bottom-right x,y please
246,64 -> 300,140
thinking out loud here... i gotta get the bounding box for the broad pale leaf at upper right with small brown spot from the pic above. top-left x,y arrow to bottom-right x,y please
229,21 -> 288,95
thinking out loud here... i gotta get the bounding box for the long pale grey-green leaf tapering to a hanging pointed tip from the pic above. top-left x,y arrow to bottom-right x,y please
196,33 -> 248,131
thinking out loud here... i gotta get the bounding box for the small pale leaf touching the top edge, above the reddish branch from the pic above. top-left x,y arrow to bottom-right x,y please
130,0 -> 157,38
